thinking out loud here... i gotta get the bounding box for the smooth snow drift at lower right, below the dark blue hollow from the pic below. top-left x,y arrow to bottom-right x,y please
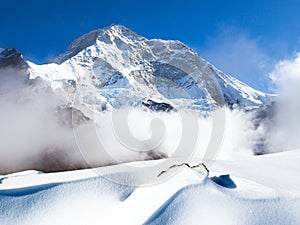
146,178 -> 300,225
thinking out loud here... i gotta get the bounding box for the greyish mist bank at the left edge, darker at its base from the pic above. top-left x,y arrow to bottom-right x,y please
0,69 -> 81,173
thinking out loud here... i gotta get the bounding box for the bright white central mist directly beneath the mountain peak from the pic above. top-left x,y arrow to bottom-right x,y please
70,108 -> 261,167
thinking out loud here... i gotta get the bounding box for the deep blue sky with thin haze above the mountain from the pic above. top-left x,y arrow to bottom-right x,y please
0,0 -> 300,91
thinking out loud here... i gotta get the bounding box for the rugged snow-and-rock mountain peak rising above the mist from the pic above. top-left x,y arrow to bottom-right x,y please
29,25 -> 271,111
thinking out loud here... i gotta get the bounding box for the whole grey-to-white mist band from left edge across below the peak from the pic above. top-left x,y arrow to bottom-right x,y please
0,70 -> 259,174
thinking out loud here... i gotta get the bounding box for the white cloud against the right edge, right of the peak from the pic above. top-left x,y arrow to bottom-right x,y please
268,53 -> 300,152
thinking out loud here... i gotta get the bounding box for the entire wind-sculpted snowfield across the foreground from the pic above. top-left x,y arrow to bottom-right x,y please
0,150 -> 300,225
